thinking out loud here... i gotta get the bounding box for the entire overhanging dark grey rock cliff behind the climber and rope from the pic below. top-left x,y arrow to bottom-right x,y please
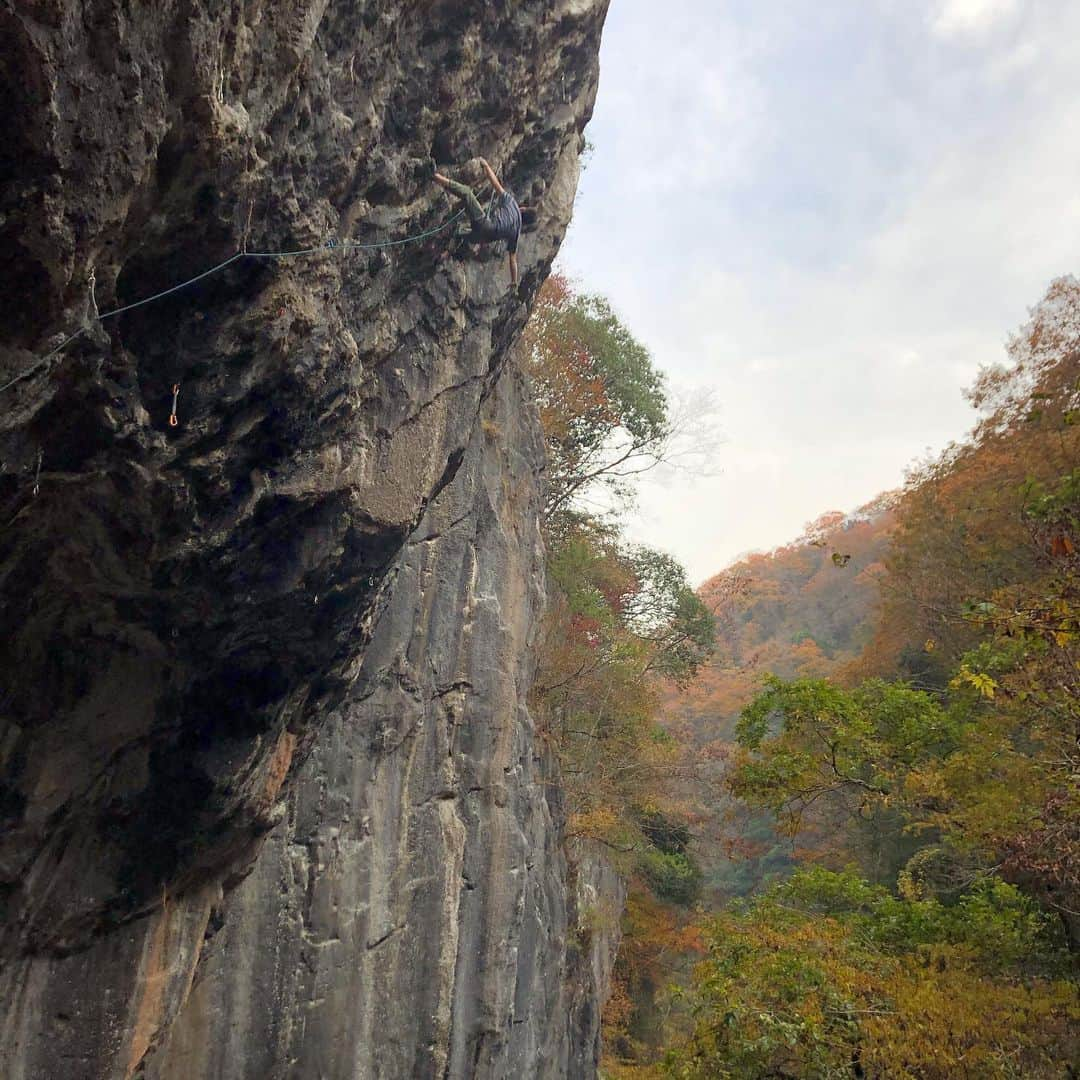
0,0 -> 606,1080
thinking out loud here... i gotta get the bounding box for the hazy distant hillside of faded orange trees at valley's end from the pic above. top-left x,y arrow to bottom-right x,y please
663,494 -> 895,903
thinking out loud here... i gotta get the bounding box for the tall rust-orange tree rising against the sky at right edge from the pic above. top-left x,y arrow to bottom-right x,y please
877,276 -> 1080,671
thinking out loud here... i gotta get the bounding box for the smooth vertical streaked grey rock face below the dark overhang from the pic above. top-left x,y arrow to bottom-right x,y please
147,367 -> 617,1080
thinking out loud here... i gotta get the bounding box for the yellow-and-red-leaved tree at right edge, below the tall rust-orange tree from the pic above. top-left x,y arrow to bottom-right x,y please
919,470 -> 1080,945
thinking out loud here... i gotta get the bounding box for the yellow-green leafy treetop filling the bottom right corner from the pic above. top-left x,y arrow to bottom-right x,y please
666,868 -> 1080,1080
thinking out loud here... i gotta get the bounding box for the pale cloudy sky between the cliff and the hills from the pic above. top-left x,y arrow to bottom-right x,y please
559,0 -> 1080,581
